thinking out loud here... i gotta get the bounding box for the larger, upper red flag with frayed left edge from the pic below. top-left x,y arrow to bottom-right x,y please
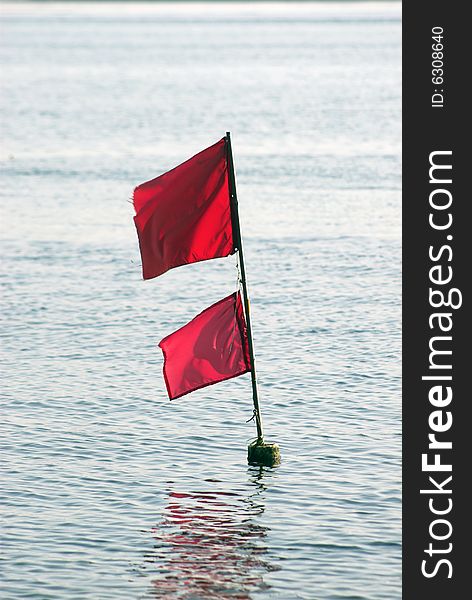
133,138 -> 234,279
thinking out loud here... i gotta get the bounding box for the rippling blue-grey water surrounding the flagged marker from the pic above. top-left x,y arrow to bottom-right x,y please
0,3 -> 401,600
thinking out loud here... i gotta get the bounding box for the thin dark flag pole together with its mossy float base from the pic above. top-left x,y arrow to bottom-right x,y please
226,131 -> 280,465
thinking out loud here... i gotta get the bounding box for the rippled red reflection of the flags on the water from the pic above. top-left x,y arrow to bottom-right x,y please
146,468 -> 276,600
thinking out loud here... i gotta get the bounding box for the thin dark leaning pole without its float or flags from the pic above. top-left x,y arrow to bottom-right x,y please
226,131 -> 264,442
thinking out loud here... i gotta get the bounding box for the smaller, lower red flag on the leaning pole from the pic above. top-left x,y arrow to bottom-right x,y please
159,292 -> 251,400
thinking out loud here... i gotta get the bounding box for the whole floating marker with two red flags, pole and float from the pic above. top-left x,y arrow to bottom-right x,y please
133,132 -> 280,466
